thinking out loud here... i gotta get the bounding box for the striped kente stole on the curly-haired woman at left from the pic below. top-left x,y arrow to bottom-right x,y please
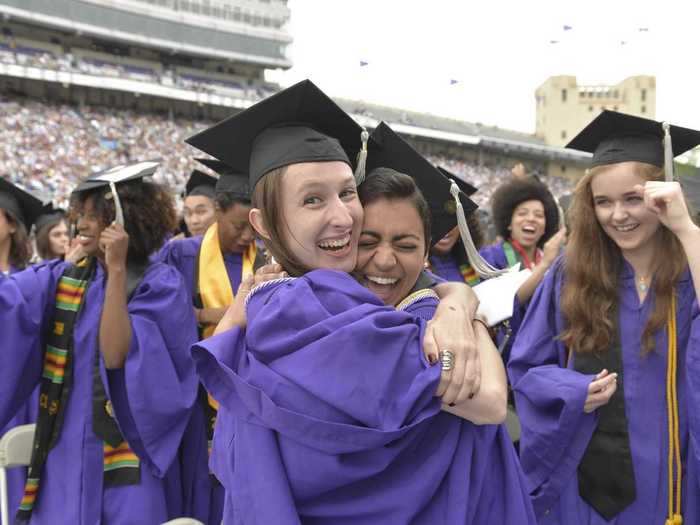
17,258 -> 140,523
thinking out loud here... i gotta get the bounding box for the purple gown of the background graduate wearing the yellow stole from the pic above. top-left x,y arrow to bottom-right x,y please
155,235 -> 243,525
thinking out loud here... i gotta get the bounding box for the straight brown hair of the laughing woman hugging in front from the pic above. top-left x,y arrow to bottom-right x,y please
251,166 -> 311,277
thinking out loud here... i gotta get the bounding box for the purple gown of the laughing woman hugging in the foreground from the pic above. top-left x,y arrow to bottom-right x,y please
193,270 -> 534,525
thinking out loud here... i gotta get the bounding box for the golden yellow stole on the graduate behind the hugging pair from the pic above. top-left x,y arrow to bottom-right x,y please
193,222 -> 257,442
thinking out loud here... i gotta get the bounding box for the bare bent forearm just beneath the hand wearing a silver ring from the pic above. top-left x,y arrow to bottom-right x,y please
442,321 -> 508,425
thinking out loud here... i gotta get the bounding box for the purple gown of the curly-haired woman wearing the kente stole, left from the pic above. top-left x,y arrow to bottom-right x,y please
0,261 -> 197,525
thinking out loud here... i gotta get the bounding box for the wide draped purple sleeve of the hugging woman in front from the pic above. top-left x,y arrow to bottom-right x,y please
193,271 -> 440,452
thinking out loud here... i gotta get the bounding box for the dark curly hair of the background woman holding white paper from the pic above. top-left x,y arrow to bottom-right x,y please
491,178 -> 559,248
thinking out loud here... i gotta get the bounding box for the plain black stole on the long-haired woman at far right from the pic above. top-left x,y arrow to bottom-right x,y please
573,309 -> 637,521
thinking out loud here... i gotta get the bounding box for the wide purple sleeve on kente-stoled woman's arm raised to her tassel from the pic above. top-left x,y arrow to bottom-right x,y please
102,263 -> 198,477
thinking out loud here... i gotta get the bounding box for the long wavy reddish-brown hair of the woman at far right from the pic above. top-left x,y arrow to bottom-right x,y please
560,162 -> 687,354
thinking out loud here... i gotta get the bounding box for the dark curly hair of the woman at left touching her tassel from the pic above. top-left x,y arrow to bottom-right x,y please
70,179 -> 177,263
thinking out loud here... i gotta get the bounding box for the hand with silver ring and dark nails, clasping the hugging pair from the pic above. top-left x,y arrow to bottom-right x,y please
423,282 -> 481,405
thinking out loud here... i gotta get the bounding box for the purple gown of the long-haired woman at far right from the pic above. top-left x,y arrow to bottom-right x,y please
508,263 -> 700,525
